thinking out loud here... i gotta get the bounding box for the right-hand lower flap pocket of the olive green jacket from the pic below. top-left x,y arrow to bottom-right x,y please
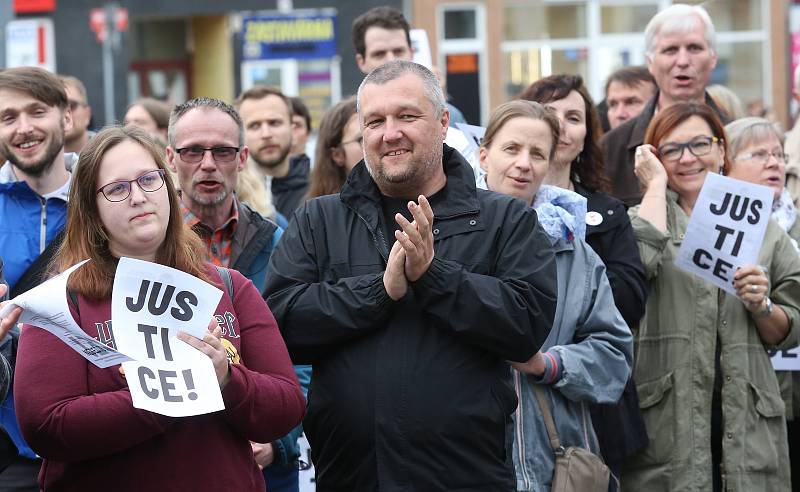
745,383 -> 788,473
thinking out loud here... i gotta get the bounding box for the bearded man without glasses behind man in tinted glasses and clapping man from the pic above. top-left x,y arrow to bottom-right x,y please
236,86 -> 311,219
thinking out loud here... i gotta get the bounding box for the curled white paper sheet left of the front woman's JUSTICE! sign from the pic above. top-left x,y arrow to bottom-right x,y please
0,260 -> 131,368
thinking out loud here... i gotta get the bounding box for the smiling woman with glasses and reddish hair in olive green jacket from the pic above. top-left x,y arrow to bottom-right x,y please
622,103 -> 800,491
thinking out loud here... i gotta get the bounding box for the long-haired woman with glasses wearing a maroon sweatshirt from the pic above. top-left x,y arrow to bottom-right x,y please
0,126 -> 305,492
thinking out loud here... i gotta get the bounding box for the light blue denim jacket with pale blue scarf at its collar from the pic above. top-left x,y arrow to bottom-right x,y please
512,187 -> 633,491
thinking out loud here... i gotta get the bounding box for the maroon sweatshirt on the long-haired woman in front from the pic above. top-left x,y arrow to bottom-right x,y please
14,267 -> 305,492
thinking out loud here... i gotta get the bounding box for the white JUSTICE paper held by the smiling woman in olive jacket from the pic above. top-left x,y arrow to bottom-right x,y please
675,173 -> 774,295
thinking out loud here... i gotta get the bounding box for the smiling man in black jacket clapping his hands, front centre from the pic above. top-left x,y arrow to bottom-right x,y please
267,60 -> 556,492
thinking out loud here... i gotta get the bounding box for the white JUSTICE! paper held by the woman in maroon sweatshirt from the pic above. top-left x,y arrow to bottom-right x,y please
111,258 -> 225,417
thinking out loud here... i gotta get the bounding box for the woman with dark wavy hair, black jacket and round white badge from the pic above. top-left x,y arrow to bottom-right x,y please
519,75 -> 647,473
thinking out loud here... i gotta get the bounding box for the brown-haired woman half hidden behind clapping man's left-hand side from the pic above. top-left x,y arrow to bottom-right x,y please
308,97 -> 364,198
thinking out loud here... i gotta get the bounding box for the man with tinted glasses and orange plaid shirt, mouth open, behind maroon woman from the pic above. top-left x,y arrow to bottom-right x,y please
167,97 -> 311,491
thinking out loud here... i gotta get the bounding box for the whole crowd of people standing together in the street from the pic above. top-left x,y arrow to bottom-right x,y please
0,1 -> 800,492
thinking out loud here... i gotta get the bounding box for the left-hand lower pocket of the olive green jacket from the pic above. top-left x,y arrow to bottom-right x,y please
636,371 -> 677,464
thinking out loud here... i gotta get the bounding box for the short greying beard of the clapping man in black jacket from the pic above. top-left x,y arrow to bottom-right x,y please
364,141 -> 442,198
